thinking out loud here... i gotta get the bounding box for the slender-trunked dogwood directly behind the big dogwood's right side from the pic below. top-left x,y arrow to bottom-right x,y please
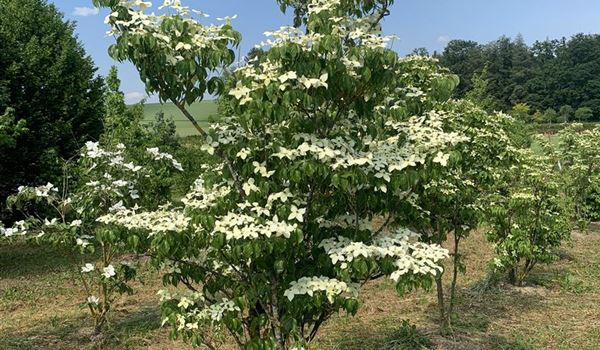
406,100 -> 517,327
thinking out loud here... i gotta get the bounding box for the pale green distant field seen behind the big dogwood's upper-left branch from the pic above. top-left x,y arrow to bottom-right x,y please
144,100 -> 217,136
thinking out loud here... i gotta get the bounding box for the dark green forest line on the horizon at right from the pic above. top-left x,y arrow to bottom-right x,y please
432,34 -> 600,122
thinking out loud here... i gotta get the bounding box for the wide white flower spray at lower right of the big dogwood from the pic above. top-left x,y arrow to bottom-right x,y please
319,229 -> 448,281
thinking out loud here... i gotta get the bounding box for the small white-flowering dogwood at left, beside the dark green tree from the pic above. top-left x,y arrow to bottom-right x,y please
0,142 -> 182,331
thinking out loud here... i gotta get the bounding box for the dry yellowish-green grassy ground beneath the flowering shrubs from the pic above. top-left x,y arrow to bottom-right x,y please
0,225 -> 600,350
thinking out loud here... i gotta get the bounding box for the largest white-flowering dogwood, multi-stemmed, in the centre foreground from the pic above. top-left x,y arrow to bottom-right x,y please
92,0 -> 474,349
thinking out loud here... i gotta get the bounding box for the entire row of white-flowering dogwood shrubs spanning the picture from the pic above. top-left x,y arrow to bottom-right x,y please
3,0 -> 598,349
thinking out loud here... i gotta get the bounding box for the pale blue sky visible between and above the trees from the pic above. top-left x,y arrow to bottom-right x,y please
48,0 -> 600,103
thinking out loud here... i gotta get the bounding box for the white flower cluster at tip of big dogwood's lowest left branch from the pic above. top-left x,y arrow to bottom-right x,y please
97,208 -> 191,236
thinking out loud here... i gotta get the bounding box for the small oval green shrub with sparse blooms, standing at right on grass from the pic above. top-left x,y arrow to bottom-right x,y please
487,150 -> 571,286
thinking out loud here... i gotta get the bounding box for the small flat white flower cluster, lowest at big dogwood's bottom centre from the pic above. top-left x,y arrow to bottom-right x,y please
283,276 -> 358,303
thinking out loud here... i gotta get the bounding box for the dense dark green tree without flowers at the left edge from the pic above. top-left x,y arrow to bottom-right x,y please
0,0 -> 103,219
